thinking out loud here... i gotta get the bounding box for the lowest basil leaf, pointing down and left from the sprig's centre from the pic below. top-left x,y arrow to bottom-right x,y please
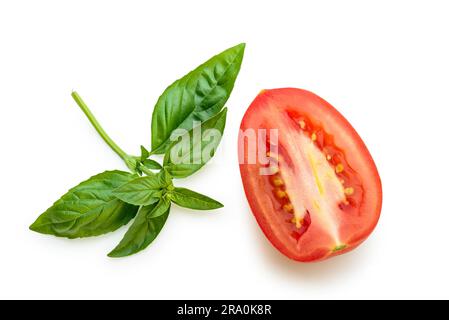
108,199 -> 170,258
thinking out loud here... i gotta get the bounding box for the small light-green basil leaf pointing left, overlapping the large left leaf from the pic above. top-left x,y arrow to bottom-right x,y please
114,170 -> 172,206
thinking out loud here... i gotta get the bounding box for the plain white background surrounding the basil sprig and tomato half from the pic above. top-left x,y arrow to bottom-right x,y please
0,0 -> 449,299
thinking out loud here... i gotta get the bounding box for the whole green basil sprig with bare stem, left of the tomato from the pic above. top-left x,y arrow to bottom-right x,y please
30,44 -> 245,257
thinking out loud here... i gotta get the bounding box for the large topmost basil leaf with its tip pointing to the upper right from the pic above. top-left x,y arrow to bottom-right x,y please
151,43 -> 245,154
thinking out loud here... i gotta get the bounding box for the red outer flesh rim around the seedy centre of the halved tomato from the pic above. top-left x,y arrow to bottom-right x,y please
239,88 -> 382,262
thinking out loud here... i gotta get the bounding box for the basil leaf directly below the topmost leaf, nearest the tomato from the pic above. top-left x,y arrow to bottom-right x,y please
164,108 -> 227,178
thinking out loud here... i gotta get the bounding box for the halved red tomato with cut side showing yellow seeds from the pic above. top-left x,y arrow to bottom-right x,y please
239,88 -> 382,262
